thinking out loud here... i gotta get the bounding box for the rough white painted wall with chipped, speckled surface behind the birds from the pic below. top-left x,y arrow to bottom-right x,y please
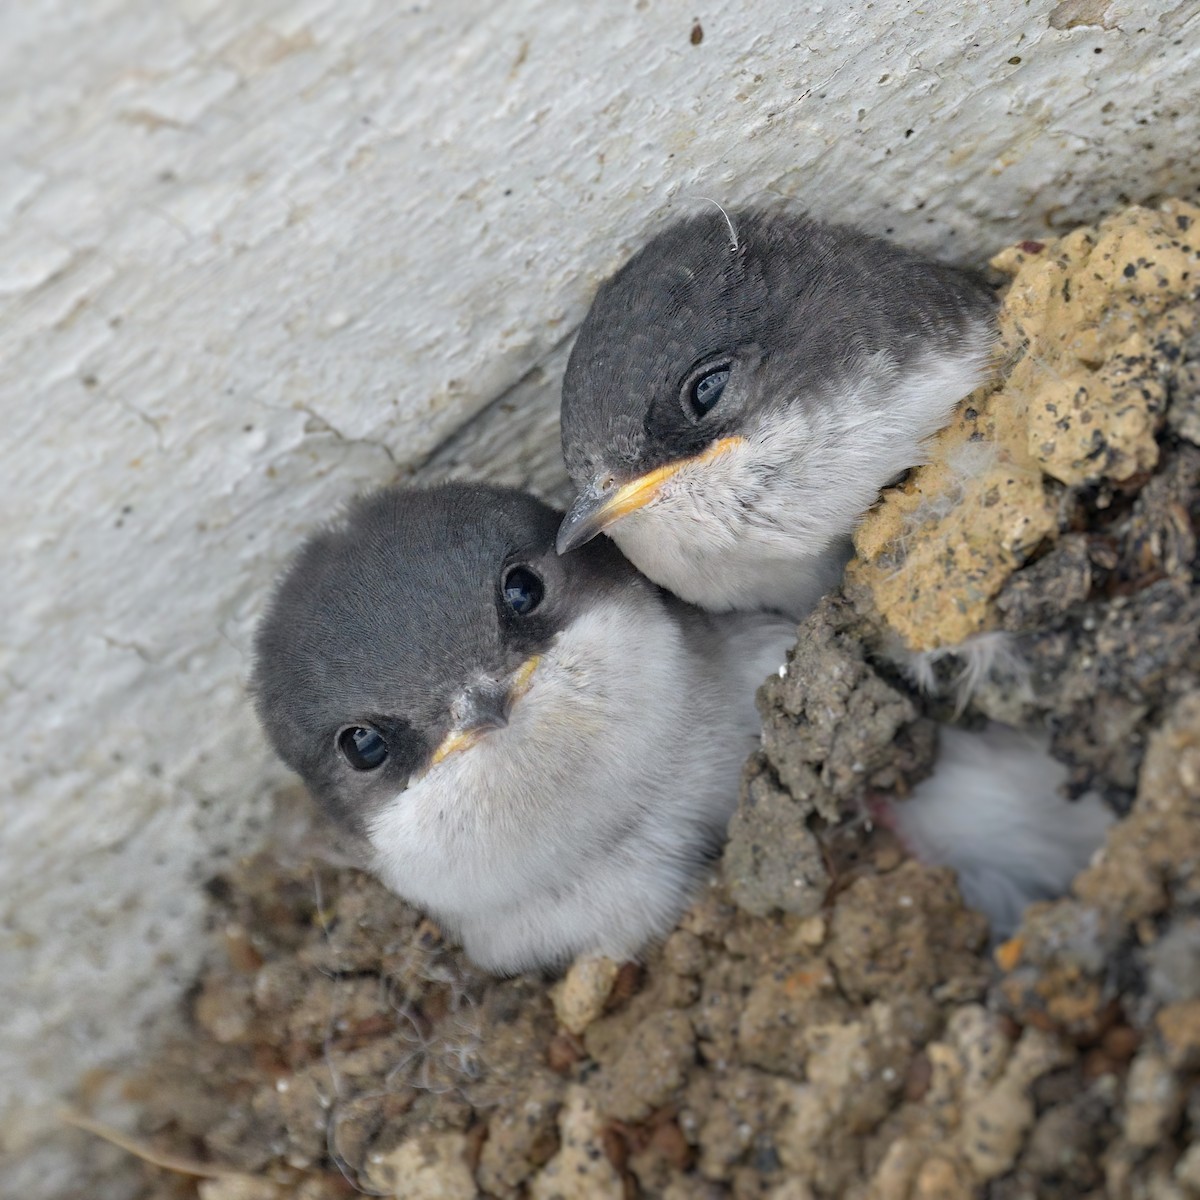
0,0 -> 1200,1195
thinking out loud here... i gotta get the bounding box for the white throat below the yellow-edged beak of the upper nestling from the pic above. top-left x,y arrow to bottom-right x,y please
611,338 -> 992,619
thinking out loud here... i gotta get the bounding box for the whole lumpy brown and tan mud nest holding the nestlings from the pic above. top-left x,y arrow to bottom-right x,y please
88,202 -> 1200,1200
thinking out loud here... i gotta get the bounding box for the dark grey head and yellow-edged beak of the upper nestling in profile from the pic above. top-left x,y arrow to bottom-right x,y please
558,210 -> 995,556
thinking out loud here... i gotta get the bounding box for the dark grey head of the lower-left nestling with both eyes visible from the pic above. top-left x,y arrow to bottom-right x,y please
252,484 -> 636,834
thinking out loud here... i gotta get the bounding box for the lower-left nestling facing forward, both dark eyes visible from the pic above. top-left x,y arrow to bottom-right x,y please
253,484 -> 794,972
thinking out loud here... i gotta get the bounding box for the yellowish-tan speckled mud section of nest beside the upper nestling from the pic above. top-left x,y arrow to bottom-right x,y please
850,202 -> 1200,650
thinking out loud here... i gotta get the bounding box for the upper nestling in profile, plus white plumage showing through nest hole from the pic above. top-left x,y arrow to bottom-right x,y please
557,211 -> 1111,935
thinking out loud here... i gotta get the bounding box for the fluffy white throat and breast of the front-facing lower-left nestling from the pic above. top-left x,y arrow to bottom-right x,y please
368,589 -> 794,971
